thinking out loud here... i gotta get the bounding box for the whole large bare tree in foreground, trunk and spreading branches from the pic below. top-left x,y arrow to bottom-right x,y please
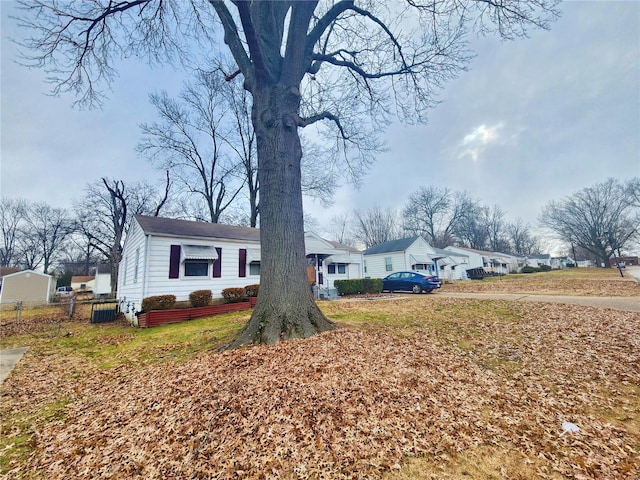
18,0 -> 558,344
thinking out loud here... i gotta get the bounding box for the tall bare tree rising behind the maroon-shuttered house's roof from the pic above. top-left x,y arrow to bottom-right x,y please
137,70 -> 246,223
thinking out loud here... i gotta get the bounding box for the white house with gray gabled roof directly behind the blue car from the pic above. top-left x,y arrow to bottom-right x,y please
362,235 -> 445,278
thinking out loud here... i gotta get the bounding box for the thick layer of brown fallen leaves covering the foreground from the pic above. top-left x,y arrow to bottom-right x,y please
2,300 -> 640,479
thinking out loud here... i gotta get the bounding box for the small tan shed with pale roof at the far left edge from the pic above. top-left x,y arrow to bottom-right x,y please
0,270 -> 56,304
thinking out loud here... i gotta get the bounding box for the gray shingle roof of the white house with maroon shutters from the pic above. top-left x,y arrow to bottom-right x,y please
135,215 -> 260,242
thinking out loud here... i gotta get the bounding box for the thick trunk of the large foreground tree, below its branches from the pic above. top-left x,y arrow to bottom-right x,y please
232,85 -> 335,347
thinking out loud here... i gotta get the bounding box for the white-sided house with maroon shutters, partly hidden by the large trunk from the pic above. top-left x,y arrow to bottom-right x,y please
117,215 -> 362,314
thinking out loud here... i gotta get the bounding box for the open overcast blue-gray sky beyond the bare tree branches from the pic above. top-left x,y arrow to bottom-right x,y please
0,1 -> 640,244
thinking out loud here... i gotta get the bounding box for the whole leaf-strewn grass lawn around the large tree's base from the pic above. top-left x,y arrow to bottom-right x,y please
0,269 -> 640,480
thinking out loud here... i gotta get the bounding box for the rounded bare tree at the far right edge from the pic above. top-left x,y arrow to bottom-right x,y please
539,178 -> 640,267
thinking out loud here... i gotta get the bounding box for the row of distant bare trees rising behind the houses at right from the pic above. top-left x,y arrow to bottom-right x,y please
328,177 -> 640,265
